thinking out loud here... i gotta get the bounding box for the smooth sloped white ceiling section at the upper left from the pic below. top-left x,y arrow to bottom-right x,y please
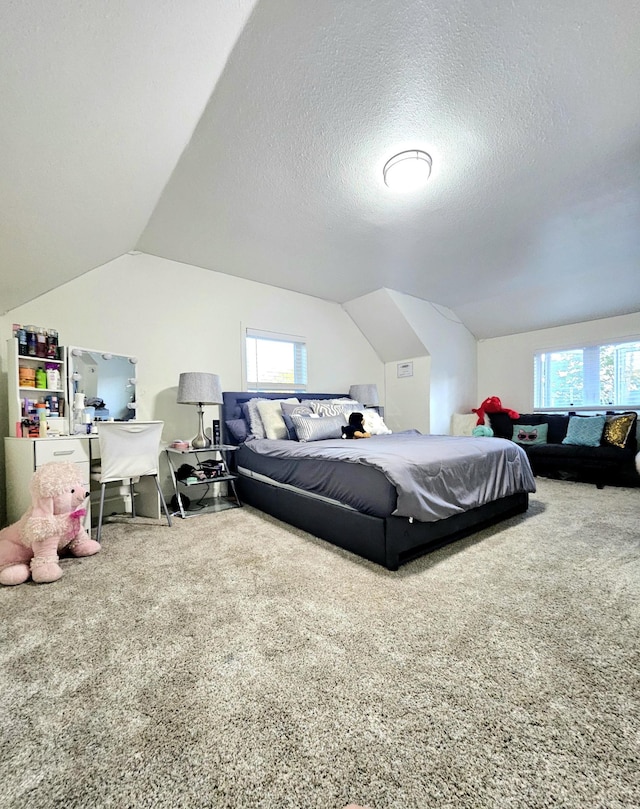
0,0 -> 255,312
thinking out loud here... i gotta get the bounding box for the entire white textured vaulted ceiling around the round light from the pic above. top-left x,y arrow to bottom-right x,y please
0,0 -> 640,338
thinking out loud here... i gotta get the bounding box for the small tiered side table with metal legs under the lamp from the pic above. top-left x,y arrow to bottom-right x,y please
165,444 -> 242,520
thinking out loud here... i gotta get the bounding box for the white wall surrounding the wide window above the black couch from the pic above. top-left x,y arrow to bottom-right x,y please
474,312 -> 640,413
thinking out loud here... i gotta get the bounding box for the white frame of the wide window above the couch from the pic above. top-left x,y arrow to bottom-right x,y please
533,335 -> 640,413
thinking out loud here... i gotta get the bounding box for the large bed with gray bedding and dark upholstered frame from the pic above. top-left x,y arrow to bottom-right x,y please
221,391 -> 535,570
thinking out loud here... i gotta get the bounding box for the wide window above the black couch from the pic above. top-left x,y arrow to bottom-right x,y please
533,341 -> 640,409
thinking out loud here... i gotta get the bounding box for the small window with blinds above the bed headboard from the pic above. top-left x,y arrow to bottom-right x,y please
245,329 -> 307,392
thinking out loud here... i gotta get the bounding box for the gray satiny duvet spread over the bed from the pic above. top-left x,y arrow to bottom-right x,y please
242,433 -> 536,522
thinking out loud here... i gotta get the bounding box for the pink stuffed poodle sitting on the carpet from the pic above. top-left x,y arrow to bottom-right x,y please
0,462 -> 100,584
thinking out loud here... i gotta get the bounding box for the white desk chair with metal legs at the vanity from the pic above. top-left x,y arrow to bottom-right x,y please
91,421 -> 171,542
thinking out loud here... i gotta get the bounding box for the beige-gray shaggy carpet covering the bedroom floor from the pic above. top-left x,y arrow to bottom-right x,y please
0,479 -> 640,809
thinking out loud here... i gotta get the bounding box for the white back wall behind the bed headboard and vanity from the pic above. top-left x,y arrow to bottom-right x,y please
0,254 -> 384,524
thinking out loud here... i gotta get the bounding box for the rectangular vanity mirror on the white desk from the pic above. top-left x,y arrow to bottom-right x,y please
68,346 -> 137,434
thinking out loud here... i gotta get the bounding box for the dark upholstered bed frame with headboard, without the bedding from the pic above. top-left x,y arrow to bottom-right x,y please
222,391 -> 529,570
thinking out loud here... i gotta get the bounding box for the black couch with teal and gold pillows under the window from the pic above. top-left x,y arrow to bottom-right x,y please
488,411 -> 640,489
